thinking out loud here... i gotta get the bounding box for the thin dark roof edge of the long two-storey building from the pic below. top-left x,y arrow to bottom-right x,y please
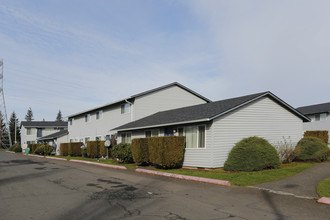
68,82 -> 212,118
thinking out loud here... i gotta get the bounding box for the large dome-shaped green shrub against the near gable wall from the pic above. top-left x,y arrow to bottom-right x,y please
224,137 -> 281,171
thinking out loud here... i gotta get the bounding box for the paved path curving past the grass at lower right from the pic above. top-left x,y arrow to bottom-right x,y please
253,161 -> 330,199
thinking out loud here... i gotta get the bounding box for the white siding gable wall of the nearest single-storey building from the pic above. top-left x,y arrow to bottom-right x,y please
209,98 -> 303,167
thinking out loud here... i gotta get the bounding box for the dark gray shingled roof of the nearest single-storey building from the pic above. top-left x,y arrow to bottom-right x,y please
113,92 -> 309,131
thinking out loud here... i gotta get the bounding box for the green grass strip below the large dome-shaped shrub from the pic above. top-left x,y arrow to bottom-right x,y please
152,163 -> 316,186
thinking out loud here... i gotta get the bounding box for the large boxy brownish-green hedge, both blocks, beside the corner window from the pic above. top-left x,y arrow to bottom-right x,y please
131,136 -> 185,169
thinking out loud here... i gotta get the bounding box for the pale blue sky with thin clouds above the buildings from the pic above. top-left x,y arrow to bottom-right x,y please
0,0 -> 330,120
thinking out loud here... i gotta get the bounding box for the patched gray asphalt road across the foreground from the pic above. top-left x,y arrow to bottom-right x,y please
0,151 -> 330,220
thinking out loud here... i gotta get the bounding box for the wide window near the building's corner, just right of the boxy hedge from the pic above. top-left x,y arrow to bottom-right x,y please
185,125 -> 205,148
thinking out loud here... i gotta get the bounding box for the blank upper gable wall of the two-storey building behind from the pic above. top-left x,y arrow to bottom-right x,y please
133,86 -> 206,120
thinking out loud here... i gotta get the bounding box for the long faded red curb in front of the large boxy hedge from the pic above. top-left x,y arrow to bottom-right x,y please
135,168 -> 231,186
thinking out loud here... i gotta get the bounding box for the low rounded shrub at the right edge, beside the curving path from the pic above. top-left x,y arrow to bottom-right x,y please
296,137 -> 329,161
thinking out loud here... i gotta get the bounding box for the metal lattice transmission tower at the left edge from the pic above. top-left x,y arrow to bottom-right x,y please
0,60 -> 12,149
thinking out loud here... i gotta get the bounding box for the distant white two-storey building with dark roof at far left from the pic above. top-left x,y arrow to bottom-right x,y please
21,121 -> 68,150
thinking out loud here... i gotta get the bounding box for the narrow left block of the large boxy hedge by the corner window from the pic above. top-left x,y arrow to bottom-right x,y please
131,138 -> 150,165
